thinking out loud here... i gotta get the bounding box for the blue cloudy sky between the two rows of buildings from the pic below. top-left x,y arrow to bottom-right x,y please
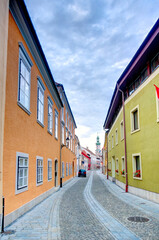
25,0 -> 159,151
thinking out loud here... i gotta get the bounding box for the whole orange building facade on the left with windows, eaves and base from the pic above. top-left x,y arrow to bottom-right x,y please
2,0 -> 76,225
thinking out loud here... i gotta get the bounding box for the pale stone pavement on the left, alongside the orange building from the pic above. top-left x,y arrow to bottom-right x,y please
0,178 -> 78,240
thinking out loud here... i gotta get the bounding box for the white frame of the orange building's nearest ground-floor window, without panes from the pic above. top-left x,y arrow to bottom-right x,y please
15,152 -> 29,194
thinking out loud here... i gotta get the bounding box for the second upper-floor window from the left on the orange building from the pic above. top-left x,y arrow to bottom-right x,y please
37,77 -> 45,126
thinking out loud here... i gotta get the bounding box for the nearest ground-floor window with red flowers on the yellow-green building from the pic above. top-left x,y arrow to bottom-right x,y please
132,153 -> 142,179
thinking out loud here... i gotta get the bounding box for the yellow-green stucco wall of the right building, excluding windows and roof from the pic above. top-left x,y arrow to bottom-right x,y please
108,65 -> 159,193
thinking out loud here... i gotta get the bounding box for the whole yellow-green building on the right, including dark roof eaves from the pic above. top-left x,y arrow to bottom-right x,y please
104,20 -> 159,202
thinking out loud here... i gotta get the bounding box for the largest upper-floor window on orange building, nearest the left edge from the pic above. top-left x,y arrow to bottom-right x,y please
18,43 -> 33,111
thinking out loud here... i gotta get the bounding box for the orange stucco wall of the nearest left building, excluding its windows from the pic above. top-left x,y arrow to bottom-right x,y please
3,13 -> 60,215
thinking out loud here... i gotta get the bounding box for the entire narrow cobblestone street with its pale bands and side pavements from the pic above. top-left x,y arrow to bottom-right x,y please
1,172 -> 159,240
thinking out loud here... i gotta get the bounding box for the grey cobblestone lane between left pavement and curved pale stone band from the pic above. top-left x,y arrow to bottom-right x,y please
60,174 -> 114,240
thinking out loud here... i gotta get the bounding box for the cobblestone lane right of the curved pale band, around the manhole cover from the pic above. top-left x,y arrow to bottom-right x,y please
92,174 -> 159,240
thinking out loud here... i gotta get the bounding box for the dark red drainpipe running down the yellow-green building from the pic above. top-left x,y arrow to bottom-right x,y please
117,85 -> 128,192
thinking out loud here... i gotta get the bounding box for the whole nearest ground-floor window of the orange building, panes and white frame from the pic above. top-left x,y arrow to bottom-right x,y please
16,153 -> 29,193
